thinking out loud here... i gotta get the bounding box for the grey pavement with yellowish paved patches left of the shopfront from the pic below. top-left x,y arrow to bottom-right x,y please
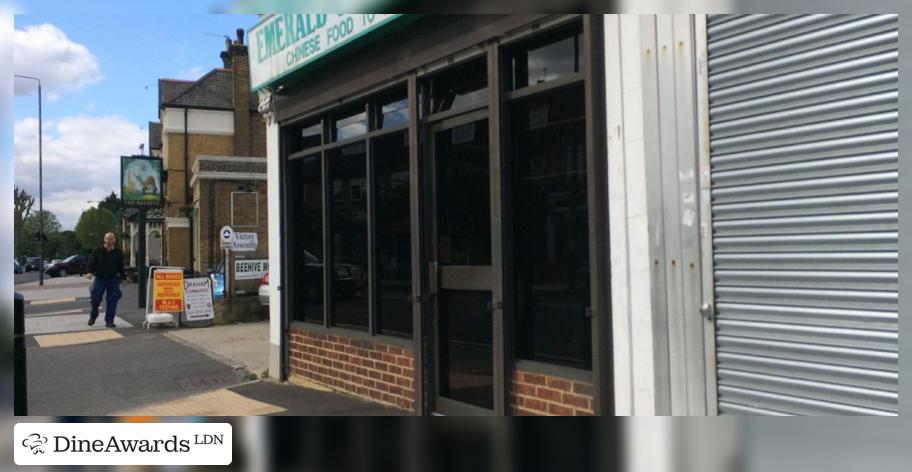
15,276 -> 404,416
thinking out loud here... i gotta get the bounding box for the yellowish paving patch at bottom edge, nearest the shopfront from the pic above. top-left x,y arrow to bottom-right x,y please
113,389 -> 285,416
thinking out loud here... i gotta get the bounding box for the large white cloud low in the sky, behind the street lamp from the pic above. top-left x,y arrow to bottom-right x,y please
13,115 -> 146,229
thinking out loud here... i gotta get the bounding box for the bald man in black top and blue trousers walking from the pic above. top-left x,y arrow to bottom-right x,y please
86,233 -> 124,328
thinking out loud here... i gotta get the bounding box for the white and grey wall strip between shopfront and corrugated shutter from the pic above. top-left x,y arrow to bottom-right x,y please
605,15 -> 706,415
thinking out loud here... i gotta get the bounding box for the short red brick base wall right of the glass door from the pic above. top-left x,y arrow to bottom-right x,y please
510,370 -> 594,416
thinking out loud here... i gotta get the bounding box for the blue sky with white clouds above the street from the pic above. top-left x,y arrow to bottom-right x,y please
13,12 -> 257,229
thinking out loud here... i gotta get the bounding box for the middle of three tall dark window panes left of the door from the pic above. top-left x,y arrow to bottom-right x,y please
327,142 -> 369,329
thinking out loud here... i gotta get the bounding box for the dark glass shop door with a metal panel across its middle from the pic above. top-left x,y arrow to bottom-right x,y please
428,110 -> 495,415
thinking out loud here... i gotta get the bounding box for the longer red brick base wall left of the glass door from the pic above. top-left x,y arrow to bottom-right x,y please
288,327 -> 415,411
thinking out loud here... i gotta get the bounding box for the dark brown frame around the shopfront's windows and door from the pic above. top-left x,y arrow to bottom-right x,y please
280,15 -> 614,415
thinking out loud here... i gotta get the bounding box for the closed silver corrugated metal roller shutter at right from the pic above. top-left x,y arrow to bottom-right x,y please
707,15 -> 899,415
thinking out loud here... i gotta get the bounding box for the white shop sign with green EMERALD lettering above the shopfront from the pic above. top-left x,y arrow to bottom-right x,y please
247,13 -> 402,91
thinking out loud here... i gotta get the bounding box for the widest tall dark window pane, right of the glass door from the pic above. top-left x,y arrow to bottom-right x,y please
510,85 -> 592,369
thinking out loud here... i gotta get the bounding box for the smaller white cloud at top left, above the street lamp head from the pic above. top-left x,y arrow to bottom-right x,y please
13,23 -> 101,100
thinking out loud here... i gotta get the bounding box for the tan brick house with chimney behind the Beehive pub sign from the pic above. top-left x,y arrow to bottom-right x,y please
150,30 -> 268,273
